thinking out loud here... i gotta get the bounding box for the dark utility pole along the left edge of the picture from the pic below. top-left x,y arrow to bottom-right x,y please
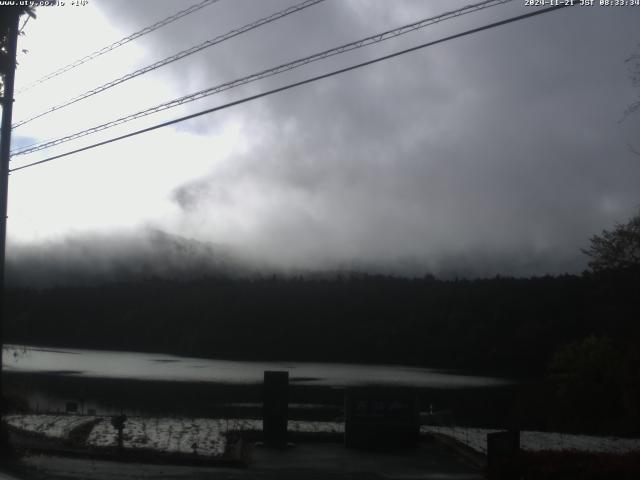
0,6 -> 32,453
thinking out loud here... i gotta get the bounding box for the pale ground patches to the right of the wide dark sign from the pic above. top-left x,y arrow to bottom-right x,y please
420,425 -> 640,453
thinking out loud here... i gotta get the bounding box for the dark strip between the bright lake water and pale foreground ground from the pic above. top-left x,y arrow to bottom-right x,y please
3,371 -> 518,427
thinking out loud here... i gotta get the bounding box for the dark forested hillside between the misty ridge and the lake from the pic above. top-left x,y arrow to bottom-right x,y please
5,272 -> 640,377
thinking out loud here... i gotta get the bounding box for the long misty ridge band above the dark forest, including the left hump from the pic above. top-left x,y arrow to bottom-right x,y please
6,228 -> 586,288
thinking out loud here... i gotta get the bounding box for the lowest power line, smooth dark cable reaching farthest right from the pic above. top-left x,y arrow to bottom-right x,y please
9,3 -> 578,172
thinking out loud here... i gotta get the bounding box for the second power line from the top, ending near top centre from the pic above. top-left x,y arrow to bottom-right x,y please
12,0 -> 325,128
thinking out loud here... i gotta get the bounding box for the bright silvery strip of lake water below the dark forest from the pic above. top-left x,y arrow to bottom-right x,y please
3,345 -> 509,389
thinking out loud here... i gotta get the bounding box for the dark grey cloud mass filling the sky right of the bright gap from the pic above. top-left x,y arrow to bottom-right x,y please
46,0 -> 640,276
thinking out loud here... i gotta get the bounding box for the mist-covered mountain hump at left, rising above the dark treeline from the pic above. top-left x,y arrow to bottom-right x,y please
7,229 -> 258,287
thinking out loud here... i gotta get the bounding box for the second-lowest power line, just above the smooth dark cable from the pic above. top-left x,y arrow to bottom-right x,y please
12,0 -> 513,156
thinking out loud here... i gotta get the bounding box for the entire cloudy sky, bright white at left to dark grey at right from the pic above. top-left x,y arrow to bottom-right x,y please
8,0 -> 640,276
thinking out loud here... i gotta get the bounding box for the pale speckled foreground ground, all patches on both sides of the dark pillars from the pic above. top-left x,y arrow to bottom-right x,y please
5,415 -> 640,456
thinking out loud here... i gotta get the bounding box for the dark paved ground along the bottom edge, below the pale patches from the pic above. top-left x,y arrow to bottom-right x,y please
0,441 -> 484,480
